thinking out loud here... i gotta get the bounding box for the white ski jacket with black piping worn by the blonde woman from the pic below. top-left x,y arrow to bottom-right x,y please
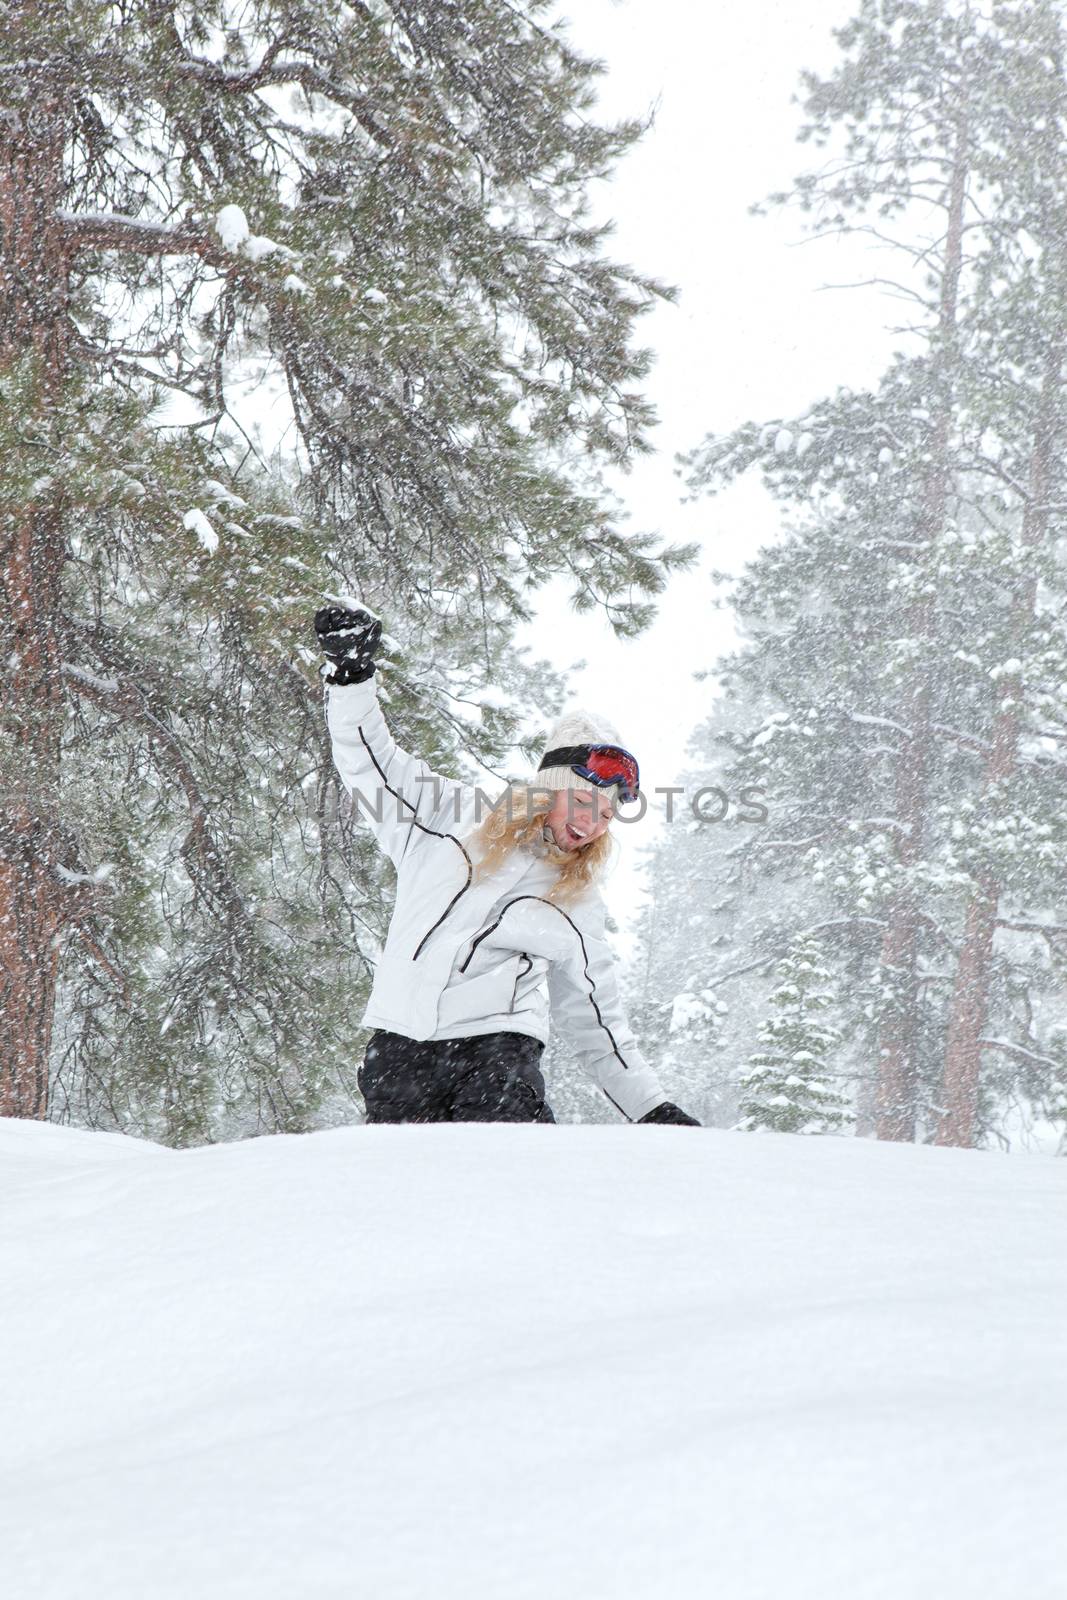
326,677 -> 667,1122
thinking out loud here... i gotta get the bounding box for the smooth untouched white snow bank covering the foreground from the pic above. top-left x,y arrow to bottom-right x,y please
0,1122 -> 1067,1600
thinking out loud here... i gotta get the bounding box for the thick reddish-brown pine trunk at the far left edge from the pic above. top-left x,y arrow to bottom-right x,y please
0,72 -> 69,1117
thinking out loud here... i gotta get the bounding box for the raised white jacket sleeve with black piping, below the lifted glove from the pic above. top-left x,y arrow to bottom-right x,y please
326,677 -> 462,867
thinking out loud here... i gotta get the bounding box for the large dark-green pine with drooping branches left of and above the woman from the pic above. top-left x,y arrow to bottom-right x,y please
0,0 -> 686,1142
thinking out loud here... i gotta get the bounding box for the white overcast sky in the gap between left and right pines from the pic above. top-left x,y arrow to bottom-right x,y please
522,0 -> 893,949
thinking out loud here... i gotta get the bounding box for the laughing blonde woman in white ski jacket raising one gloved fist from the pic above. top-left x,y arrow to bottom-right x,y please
315,605 -> 696,1126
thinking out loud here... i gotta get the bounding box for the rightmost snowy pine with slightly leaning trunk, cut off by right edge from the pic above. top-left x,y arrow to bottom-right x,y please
934,5 -> 1067,1146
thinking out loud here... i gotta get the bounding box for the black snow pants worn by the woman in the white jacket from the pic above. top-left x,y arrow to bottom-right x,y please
358,1030 -> 555,1122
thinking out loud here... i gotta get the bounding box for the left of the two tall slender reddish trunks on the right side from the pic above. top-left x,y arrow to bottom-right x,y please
875,96 -> 969,1141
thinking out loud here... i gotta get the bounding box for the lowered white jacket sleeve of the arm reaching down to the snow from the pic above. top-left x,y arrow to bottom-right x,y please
549,898 -> 667,1122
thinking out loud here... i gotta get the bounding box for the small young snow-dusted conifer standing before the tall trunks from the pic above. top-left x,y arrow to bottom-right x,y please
737,941 -> 851,1133
